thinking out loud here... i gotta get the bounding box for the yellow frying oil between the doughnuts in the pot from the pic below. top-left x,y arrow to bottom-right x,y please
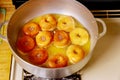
16,14 -> 90,67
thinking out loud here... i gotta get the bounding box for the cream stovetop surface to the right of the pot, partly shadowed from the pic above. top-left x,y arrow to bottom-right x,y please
82,17 -> 120,80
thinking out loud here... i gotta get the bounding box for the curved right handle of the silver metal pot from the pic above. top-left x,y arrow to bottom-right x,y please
96,18 -> 107,39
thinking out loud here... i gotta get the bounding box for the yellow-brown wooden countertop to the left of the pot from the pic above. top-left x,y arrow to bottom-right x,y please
0,0 -> 15,80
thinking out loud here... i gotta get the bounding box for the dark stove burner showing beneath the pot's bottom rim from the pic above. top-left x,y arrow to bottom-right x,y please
23,70 -> 81,80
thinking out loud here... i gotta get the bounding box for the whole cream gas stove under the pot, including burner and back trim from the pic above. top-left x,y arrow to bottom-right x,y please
10,0 -> 120,80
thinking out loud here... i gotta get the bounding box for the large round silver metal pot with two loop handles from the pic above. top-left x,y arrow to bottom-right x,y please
0,0 -> 106,78
